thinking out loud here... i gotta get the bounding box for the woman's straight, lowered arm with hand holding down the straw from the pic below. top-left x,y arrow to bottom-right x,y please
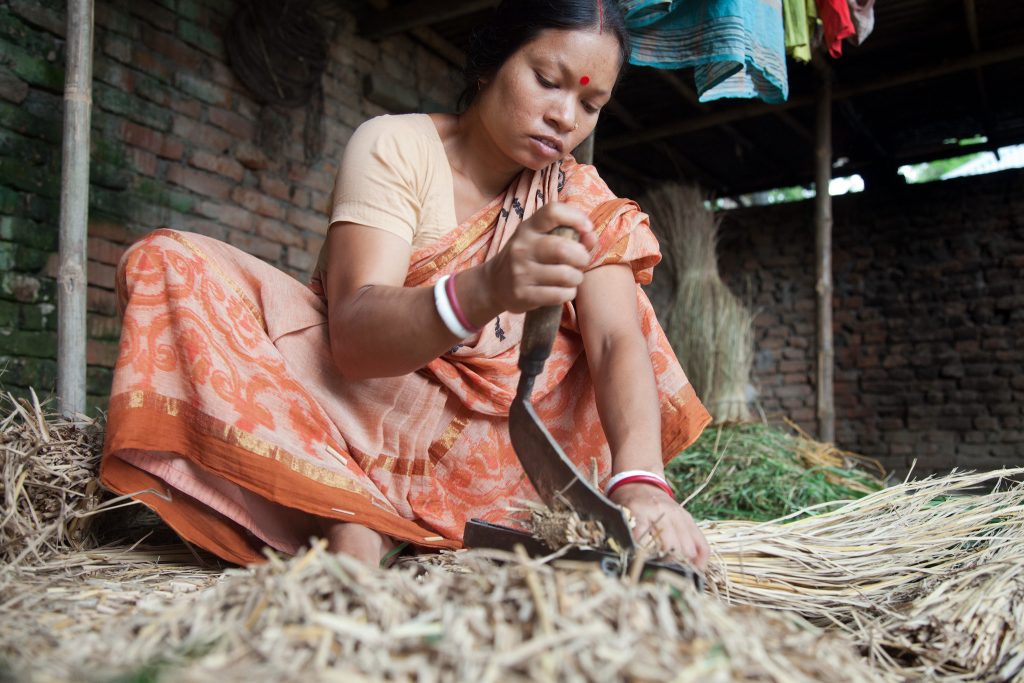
575,264 -> 710,569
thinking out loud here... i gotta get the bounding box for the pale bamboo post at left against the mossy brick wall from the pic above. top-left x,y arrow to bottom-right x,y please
57,0 -> 93,415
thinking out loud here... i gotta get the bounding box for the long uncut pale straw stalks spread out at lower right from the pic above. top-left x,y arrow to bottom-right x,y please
705,468 -> 1024,680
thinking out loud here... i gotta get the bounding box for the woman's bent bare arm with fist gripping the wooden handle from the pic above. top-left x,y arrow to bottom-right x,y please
324,203 -> 595,379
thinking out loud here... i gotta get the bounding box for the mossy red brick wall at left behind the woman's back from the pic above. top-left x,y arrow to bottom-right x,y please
0,0 -> 459,411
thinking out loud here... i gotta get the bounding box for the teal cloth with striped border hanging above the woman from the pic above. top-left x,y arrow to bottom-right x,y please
622,0 -> 790,104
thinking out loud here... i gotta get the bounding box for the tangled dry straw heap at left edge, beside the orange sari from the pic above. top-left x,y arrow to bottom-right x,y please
0,392 -> 102,568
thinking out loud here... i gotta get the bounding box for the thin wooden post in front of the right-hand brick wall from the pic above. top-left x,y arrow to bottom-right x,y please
814,69 -> 836,442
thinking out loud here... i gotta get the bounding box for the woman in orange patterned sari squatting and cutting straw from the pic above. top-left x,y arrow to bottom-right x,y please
101,0 -> 710,565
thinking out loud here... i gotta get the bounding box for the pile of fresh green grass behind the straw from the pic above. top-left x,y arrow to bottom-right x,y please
666,423 -> 885,521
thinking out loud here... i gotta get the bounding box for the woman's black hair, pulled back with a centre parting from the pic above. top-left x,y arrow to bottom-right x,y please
459,0 -> 630,111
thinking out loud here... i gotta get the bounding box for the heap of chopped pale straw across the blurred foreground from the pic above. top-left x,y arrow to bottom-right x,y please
0,546 -> 879,683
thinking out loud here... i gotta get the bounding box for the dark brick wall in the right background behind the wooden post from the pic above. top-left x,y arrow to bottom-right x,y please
720,171 -> 1024,472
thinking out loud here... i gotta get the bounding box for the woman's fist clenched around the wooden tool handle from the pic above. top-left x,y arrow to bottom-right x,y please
484,202 -> 597,313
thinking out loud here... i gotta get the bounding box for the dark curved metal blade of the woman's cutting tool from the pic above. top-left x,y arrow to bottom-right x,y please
509,395 -> 635,553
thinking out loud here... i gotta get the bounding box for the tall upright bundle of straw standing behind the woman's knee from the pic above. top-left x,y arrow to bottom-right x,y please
640,184 -> 754,423
